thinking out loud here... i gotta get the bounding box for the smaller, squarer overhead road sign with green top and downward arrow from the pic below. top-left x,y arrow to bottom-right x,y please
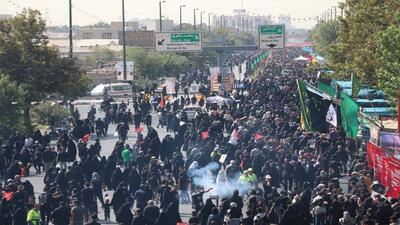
258,25 -> 285,49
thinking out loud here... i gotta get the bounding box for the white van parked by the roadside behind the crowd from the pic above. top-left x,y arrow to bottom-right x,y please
90,83 -> 133,96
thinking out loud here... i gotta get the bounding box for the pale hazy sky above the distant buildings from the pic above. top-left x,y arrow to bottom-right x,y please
0,0 -> 343,27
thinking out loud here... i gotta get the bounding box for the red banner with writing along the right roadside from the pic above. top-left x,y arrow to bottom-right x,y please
367,142 -> 400,198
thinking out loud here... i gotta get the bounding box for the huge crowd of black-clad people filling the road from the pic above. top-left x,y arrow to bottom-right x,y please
0,49 -> 400,225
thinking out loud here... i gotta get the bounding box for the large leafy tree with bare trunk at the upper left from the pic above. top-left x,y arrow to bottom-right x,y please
0,9 -> 88,131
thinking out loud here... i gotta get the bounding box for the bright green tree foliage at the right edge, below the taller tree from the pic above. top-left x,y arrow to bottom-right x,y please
376,26 -> 400,102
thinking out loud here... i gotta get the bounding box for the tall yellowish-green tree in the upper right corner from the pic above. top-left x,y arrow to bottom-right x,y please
327,0 -> 400,83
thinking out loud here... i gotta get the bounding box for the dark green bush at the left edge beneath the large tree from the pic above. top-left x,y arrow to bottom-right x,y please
0,74 -> 23,135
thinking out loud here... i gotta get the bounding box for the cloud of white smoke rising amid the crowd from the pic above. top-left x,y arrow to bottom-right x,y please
188,162 -> 252,199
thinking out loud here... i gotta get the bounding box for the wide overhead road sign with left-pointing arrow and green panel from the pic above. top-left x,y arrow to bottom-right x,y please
155,32 -> 203,52
